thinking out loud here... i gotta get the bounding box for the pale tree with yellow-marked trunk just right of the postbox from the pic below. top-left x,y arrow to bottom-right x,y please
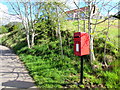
88,0 -> 116,62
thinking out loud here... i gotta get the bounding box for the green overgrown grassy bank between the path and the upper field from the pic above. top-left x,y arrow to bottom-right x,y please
1,21 -> 120,88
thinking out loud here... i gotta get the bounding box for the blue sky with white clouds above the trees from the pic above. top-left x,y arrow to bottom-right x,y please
0,0 -> 119,25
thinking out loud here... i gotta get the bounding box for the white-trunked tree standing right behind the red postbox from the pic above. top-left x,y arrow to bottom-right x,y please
73,0 -> 118,64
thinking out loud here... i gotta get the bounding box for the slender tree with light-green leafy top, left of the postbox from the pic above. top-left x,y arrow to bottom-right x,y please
39,1 -> 65,56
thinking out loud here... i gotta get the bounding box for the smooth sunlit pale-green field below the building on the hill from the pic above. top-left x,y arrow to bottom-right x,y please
62,19 -> 120,47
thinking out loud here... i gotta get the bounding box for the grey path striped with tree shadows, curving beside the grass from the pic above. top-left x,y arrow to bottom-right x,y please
0,45 -> 36,90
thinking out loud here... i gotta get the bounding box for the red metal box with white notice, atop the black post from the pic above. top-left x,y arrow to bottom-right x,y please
74,32 -> 90,56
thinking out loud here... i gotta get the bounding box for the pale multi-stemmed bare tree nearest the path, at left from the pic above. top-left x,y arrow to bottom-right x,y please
9,0 -> 41,48
